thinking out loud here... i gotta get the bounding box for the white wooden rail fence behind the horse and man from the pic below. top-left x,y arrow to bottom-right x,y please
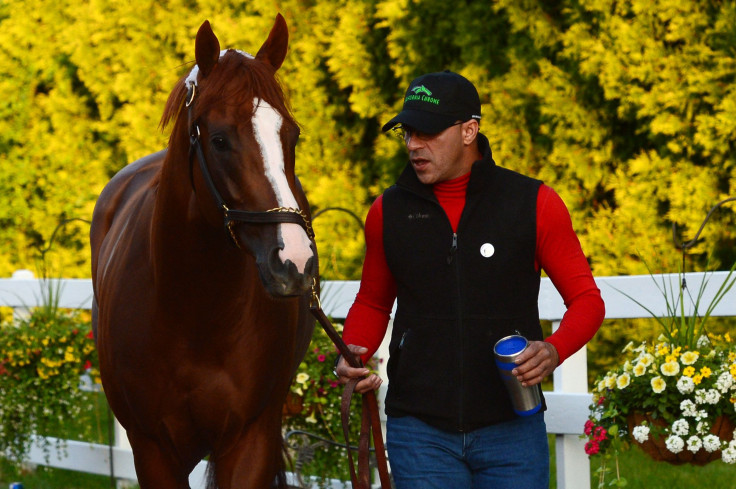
0,272 -> 736,489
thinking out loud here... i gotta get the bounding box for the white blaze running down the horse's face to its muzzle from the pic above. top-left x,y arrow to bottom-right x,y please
252,98 -> 314,273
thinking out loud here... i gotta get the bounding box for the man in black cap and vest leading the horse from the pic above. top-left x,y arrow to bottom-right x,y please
336,71 -> 604,489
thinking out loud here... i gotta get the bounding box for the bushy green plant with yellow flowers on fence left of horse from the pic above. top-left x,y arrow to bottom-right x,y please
0,282 -> 99,462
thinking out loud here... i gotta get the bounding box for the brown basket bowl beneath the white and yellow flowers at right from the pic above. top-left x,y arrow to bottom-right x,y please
626,412 -> 736,465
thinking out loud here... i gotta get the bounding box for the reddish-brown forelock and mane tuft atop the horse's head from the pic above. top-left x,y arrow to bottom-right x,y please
159,50 -> 294,132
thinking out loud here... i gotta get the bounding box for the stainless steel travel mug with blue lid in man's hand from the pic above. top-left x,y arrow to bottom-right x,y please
493,335 -> 542,416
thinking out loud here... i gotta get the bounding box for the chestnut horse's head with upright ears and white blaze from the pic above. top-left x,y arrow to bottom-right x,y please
162,15 -> 317,296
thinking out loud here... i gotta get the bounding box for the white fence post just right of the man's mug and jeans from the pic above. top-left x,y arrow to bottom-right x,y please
552,321 -> 590,489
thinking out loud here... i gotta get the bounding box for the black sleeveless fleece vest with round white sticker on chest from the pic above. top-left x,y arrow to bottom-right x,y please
383,135 -> 542,431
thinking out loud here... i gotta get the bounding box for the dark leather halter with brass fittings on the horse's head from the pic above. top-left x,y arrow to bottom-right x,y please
185,83 -> 314,248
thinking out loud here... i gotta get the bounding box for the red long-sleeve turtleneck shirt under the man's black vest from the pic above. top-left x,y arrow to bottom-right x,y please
343,173 -> 605,363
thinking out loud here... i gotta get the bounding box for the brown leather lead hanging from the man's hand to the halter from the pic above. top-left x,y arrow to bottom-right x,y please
309,280 -> 391,489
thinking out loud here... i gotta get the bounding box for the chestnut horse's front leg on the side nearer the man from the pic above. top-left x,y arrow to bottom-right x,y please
210,414 -> 284,489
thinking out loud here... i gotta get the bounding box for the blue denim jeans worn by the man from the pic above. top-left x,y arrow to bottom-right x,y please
386,412 -> 549,489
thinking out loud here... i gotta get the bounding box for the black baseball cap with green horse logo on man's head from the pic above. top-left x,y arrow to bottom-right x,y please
382,71 -> 480,134
